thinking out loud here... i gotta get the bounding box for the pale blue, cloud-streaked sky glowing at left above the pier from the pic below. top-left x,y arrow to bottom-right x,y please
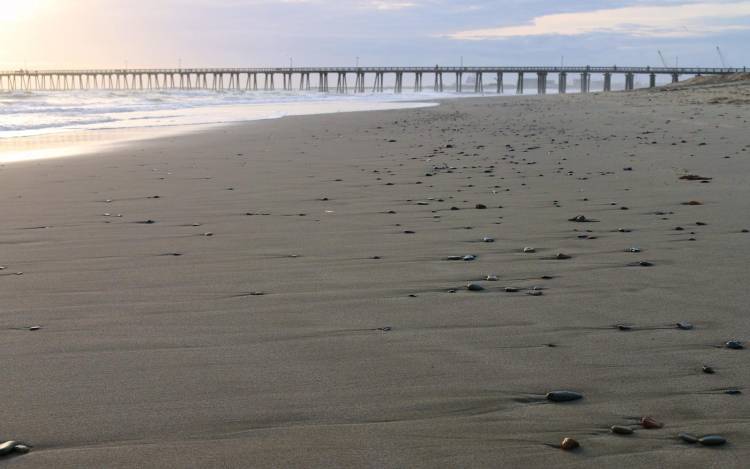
0,0 -> 750,69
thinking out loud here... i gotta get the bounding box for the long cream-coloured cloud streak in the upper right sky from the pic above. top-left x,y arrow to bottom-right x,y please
448,1 -> 750,40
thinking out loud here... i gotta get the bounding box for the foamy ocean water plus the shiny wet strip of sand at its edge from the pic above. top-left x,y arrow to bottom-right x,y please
0,90 -> 458,164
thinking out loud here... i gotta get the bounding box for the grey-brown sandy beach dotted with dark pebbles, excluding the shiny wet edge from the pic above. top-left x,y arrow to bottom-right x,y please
0,80 -> 750,469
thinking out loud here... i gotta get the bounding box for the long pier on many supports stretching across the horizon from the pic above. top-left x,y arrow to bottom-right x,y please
0,66 -> 746,94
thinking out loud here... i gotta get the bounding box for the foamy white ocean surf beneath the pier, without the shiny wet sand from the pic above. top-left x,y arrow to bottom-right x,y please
0,90 -> 452,139
